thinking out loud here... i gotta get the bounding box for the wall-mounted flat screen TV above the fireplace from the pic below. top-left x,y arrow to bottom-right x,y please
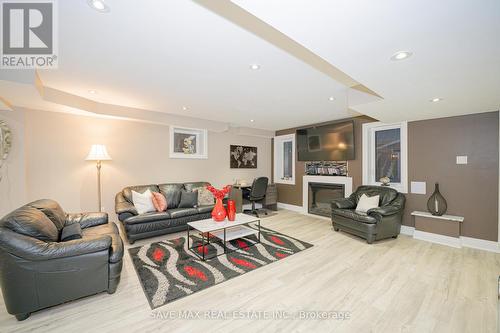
297,120 -> 355,161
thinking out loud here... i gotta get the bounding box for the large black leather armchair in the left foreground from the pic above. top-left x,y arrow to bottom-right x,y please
0,199 -> 123,320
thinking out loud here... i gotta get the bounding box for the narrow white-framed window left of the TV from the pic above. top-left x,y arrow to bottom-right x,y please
274,134 -> 295,185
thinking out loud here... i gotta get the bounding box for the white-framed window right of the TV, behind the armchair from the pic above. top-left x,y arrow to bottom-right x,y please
363,122 -> 408,193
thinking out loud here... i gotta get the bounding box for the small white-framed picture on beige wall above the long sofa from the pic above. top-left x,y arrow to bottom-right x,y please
170,126 -> 208,159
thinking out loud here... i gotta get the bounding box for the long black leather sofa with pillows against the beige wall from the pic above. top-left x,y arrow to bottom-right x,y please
115,182 -> 227,244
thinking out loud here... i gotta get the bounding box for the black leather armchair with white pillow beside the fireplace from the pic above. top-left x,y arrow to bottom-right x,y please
332,186 -> 405,244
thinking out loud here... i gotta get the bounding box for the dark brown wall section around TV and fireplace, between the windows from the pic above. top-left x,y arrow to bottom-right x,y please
273,116 -> 375,206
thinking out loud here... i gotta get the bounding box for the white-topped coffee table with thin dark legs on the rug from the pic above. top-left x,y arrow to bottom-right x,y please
187,213 -> 260,260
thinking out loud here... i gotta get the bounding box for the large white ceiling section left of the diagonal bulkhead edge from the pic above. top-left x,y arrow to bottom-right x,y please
40,0 -> 368,130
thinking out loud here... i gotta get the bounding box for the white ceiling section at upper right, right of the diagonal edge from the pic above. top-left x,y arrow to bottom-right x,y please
233,0 -> 500,121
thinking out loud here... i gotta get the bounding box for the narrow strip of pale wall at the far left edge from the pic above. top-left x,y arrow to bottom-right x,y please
0,110 -> 26,217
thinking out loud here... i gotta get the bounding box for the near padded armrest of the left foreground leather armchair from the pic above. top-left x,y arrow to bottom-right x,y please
0,228 -> 111,261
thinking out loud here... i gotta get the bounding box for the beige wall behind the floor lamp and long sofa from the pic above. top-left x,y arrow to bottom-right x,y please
25,111 -> 271,218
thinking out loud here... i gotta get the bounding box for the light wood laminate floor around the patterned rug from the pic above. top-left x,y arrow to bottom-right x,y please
0,210 -> 500,333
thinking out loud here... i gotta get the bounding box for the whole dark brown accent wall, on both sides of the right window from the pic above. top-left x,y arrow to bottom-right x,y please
276,112 -> 499,241
